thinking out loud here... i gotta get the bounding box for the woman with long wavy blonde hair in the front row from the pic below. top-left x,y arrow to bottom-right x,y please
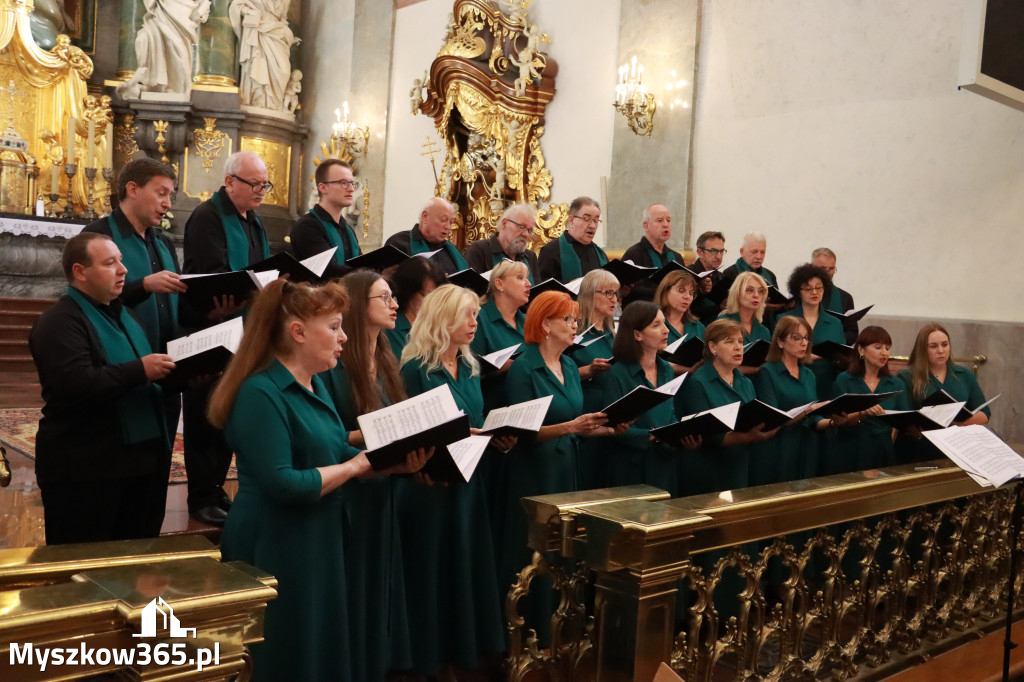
398,285 -> 514,679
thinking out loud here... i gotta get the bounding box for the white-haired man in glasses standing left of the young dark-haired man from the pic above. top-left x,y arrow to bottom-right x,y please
182,152 -> 273,525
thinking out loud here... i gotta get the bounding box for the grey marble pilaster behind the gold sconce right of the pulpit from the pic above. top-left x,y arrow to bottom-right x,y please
605,0 -> 700,251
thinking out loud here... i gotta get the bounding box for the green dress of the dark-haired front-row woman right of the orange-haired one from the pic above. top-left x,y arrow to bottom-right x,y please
600,357 -> 685,497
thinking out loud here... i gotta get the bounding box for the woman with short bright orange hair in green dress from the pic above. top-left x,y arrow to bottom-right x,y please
498,291 -> 626,642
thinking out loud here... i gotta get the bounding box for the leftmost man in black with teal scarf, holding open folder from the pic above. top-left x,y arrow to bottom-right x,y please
29,232 -> 174,545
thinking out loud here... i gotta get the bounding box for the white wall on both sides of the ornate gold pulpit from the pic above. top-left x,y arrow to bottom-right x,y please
384,0 -> 620,243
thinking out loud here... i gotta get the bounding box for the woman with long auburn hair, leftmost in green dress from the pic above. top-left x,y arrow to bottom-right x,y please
209,280 -> 427,680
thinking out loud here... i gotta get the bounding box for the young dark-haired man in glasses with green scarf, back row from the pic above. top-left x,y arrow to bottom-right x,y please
289,159 -> 362,279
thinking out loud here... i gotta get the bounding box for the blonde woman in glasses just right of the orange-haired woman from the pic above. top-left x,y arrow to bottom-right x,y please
569,268 -> 620,491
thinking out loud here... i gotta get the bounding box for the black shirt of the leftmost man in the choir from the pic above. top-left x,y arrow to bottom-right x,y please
29,296 -> 167,485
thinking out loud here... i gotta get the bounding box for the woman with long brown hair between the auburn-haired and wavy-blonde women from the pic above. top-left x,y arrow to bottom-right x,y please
321,270 -> 413,681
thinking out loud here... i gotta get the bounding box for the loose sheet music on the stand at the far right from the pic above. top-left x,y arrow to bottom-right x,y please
925,424 -> 1024,486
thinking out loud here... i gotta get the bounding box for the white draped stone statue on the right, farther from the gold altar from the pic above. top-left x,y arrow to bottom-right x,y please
227,0 -> 299,112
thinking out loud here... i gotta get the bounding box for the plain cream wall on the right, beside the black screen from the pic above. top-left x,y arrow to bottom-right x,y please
688,0 -> 1024,323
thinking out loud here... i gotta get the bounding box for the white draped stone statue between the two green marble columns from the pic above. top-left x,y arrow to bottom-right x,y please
118,0 -> 210,99
